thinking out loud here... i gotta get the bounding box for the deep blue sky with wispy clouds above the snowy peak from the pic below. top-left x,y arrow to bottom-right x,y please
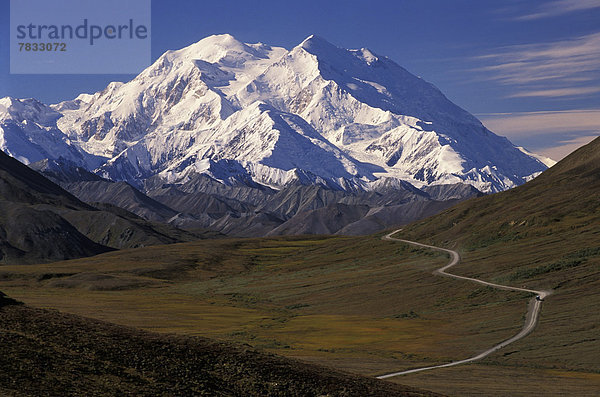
0,0 -> 600,159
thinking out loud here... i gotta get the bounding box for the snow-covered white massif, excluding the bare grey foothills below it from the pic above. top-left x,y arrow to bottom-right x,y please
0,35 -> 546,191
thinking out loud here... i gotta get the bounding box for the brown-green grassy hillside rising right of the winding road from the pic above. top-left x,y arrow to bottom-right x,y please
384,138 -> 600,392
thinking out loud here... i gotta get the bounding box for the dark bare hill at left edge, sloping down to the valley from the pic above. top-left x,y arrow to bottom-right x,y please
0,151 -> 210,264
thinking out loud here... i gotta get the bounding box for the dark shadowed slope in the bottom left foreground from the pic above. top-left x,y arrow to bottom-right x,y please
0,293 -> 439,397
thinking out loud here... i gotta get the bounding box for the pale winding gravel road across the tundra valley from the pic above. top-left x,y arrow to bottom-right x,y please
377,229 -> 552,379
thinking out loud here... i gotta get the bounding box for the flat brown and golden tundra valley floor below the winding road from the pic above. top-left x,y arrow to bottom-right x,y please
0,232 -> 600,396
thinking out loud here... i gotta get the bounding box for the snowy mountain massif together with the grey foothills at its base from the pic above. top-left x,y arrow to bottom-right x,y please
0,34 -> 553,236
